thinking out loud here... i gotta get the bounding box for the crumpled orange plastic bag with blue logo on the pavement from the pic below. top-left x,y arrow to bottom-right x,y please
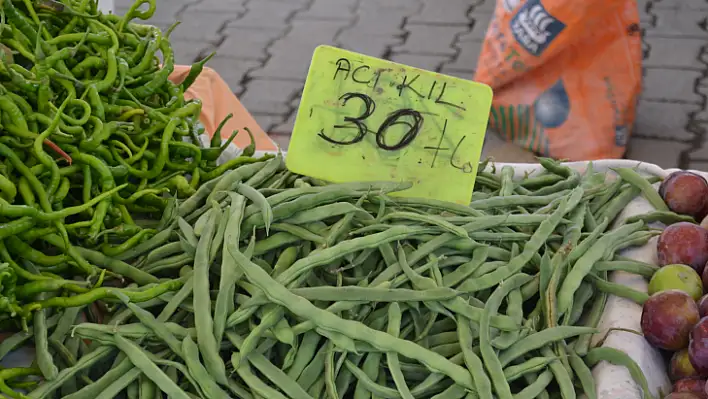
475,0 -> 642,161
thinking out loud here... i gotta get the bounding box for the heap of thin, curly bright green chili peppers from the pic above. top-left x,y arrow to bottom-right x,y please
0,0 -> 266,328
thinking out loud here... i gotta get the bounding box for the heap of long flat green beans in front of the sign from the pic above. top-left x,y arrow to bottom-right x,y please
0,156 -> 677,399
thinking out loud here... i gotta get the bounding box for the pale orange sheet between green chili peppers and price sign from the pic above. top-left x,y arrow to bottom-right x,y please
170,65 -> 278,151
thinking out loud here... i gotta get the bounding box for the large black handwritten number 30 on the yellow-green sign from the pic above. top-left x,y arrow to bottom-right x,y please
318,93 -> 423,151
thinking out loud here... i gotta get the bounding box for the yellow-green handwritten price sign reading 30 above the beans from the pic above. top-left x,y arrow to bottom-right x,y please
286,46 -> 492,204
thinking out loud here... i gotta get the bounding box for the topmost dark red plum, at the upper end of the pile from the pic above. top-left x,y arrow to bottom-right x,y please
659,171 -> 708,217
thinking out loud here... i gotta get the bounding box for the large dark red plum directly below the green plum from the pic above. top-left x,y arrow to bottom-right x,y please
641,290 -> 700,350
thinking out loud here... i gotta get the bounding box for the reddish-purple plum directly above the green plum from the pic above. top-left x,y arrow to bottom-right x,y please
656,222 -> 708,275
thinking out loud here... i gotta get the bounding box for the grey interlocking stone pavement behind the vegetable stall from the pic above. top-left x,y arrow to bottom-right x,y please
116,0 -> 708,171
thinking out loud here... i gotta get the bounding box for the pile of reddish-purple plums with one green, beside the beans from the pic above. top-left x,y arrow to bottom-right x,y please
641,171 -> 708,399
